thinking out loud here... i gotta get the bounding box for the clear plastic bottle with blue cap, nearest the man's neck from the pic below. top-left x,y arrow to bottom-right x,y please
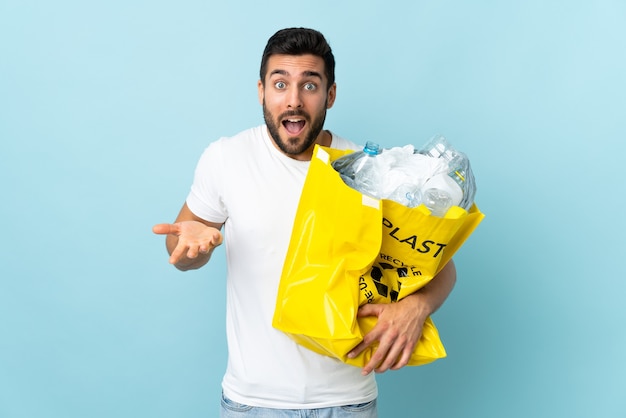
332,141 -> 384,198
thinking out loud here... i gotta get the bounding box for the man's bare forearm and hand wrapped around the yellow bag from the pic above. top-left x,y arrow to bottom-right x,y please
348,260 -> 456,374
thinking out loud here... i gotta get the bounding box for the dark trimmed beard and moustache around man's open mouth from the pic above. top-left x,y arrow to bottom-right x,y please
263,100 -> 326,155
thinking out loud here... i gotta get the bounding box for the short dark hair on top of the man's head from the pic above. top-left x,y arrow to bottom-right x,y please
260,28 -> 335,88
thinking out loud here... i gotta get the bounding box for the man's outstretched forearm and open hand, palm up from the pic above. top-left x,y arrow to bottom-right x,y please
152,203 -> 223,271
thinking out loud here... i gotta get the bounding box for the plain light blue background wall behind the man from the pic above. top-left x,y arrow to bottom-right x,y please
0,0 -> 626,418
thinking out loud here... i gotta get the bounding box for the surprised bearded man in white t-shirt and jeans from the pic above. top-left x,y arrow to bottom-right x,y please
154,28 -> 456,417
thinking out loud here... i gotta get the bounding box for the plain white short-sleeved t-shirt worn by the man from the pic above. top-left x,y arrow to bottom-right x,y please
187,125 -> 377,409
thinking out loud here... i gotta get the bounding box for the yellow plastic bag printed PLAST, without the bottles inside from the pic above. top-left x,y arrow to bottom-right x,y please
272,146 -> 484,367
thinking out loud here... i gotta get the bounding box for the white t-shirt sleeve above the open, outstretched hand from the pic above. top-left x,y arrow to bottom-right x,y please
186,140 -> 228,223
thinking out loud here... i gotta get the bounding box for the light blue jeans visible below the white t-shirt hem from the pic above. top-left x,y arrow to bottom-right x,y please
220,394 -> 378,418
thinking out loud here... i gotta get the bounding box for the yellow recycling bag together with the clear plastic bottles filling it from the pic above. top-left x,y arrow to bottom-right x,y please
272,136 -> 484,367
